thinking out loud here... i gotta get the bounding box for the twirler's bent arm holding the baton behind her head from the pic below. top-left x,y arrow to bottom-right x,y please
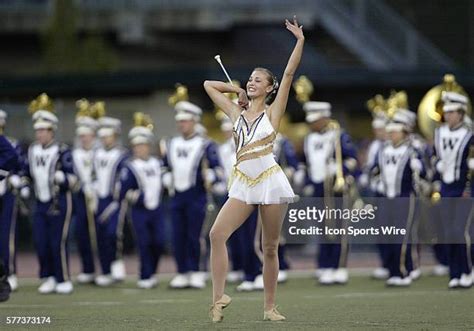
204,80 -> 248,123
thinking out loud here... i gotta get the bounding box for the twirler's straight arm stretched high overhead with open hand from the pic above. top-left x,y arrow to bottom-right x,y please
268,16 -> 304,129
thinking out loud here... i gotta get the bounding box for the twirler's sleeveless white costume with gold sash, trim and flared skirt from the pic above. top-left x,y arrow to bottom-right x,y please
229,111 -> 298,204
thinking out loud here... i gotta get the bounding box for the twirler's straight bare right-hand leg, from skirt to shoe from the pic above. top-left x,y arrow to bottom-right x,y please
260,204 -> 288,311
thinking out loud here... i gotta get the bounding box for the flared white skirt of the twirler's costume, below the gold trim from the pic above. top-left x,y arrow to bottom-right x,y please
229,166 -> 299,205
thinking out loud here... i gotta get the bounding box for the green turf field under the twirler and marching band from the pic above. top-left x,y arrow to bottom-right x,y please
0,276 -> 474,331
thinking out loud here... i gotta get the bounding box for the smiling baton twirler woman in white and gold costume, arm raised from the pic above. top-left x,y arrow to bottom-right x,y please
204,17 -> 304,322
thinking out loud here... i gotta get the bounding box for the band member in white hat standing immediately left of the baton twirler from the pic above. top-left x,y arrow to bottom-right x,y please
163,101 -> 222,289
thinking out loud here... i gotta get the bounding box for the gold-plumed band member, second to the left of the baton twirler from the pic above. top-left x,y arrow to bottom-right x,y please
119,113 -> 165,289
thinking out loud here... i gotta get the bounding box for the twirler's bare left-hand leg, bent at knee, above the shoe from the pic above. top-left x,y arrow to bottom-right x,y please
209,198 -> 255,303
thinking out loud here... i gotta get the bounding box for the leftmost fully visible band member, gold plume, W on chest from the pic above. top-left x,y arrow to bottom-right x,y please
25,94 -> 77,294
